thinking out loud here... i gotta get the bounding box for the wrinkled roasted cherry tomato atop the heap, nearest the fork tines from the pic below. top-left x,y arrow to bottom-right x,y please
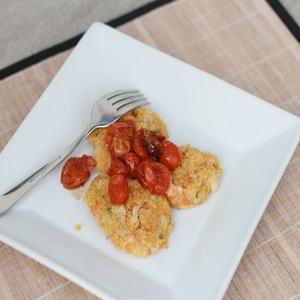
105,121 -> 135,158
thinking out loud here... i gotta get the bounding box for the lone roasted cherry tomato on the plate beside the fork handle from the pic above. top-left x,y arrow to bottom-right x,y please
61,154 -> 97,189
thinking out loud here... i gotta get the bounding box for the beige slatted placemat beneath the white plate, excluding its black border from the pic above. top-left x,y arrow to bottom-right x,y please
0,0 -> 300,300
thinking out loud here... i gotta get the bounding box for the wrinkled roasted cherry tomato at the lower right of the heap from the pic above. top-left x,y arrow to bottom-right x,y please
137,158 -> 171,195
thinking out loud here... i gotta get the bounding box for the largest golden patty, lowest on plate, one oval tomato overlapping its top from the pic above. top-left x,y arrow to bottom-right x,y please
84,174 -> 173,256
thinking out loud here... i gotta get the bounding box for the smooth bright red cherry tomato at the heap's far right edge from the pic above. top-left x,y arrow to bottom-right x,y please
159,140 -> 182,170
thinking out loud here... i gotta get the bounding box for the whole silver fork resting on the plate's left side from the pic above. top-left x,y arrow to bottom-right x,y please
0,90 -> 150,216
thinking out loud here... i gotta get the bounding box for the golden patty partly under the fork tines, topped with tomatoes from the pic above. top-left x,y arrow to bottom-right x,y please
88,106 -> 168,172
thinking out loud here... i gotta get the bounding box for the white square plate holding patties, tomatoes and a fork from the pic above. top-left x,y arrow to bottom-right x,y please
0,23 -> 300,300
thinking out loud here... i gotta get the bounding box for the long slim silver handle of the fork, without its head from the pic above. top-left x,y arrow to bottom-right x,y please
0,125 -> 93,216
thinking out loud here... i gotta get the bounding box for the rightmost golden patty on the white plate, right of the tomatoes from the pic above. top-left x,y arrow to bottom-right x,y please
166,145 -> 222,208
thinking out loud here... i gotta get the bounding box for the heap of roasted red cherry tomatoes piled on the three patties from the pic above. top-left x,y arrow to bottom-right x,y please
101,121 -> 182,204
